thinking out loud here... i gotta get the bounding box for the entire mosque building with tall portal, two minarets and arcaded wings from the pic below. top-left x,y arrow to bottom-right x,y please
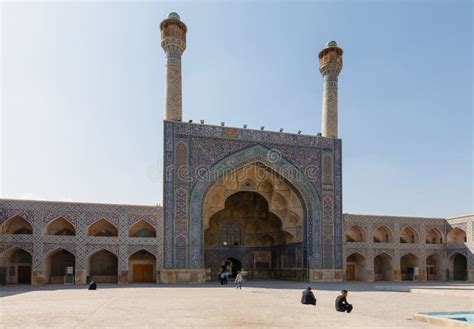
0,13 -> 474,285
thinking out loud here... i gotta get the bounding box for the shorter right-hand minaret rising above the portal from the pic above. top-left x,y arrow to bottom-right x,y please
319,41 -> 342,138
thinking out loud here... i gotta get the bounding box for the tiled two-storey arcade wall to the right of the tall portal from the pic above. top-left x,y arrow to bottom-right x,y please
344,214 -> 474,281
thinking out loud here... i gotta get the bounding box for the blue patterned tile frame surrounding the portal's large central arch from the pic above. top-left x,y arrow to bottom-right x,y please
163,121 -> 343,268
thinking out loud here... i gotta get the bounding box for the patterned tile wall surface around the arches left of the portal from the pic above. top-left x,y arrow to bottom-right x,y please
0,199 -> 163,269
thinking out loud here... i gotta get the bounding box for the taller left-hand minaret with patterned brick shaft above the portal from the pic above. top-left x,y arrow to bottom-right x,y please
160,13 -> 188,121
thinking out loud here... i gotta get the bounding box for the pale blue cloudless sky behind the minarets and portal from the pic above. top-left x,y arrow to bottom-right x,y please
0,1 -> 474,217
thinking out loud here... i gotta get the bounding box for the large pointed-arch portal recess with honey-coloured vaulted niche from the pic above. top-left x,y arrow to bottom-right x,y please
203,163 -> 307,280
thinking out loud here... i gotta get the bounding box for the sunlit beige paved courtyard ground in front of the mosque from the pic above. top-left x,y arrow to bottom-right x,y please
0,281 -> 474,329
